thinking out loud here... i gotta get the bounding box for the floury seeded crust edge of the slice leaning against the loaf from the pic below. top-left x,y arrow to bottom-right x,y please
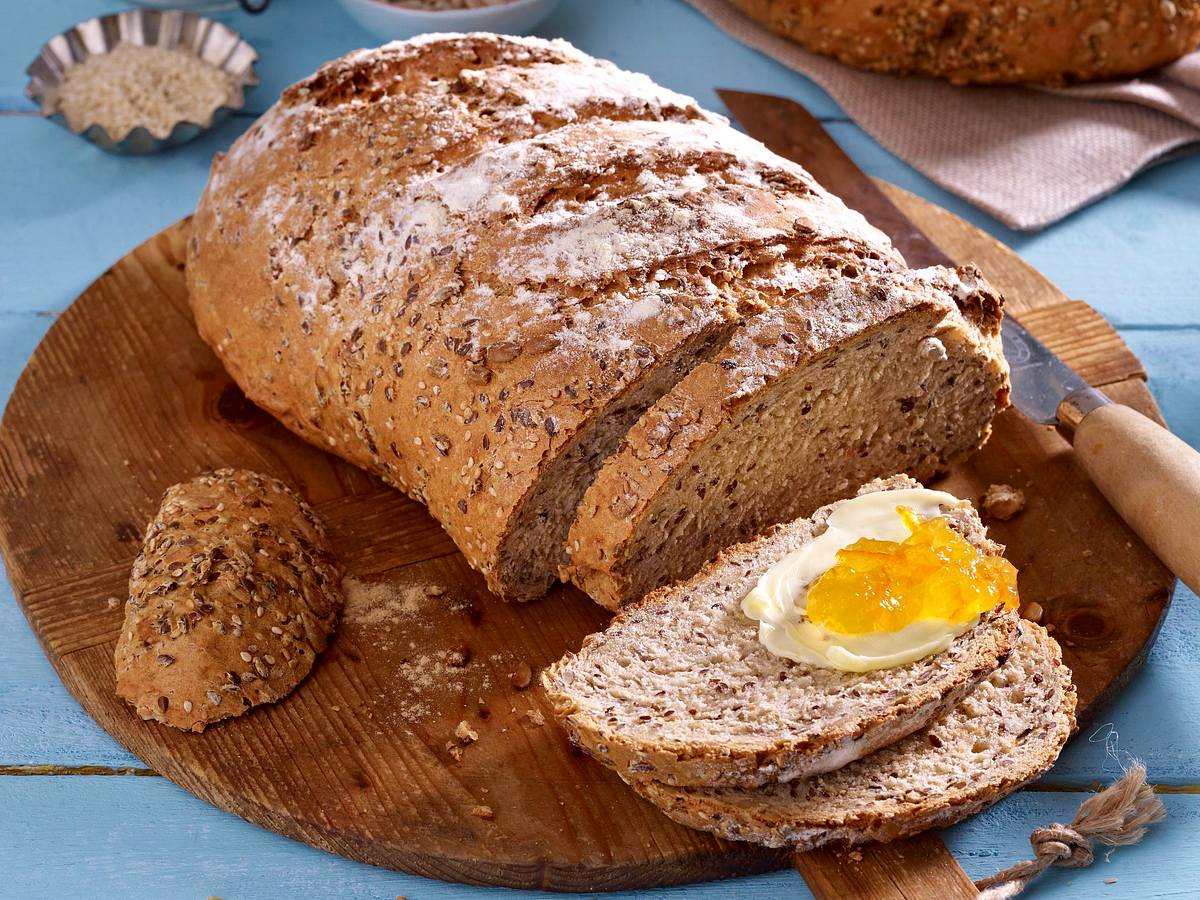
562,266 -> 1008,608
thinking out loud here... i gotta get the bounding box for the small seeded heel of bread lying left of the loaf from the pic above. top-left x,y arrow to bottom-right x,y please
115,469 -> 342,731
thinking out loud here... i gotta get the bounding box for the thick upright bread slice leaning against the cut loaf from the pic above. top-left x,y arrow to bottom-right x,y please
562,268 -> 1008,610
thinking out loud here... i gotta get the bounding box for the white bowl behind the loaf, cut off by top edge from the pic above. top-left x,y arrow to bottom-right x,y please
338,0 -> 559,41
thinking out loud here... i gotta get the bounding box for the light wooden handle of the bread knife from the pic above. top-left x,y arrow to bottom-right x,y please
1074,403 -> 1200,594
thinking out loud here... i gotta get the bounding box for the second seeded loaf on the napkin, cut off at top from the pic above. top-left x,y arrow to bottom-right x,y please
733,0 -> 1200,85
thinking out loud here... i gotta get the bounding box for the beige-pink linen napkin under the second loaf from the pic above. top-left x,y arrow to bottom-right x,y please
688,0 -> 1200,230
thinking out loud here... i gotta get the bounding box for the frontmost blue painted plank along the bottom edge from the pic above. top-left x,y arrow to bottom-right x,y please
0,776 -> 1200,900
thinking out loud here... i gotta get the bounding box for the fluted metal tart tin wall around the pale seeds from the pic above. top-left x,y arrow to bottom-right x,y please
25,10 -> 258,154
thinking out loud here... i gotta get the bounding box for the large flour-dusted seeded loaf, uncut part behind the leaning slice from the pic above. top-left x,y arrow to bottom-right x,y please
187,35 -> 902,598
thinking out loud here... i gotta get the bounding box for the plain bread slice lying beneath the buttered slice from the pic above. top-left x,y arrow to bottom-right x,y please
626,622 -> 1075,851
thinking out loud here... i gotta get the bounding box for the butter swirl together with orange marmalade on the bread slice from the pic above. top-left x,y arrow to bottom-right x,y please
742,488 -> 1018,672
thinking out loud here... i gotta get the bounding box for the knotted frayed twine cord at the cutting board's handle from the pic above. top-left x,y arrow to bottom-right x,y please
976,762 -> 1166,900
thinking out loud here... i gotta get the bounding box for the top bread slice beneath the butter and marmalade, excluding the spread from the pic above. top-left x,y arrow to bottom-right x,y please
542,476 -> 1016,787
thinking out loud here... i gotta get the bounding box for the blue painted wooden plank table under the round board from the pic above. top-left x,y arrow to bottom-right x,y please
0,0 -> 1200,900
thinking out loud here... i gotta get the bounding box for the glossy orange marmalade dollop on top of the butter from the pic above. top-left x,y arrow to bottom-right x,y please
806,506 -> 1018,635
